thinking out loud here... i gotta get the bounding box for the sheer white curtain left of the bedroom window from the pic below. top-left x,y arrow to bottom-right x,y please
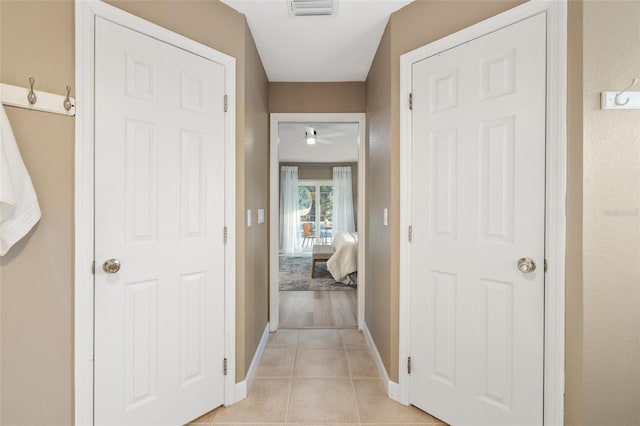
280,166 -> 302,255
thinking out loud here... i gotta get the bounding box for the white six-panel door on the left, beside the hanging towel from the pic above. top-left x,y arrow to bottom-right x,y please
94,18 -> 225,425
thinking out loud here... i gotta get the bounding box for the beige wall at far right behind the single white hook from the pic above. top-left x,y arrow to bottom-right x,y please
583,1 -> 640,425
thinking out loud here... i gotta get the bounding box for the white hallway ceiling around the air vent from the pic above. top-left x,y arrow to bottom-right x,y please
222,0 -> 413,82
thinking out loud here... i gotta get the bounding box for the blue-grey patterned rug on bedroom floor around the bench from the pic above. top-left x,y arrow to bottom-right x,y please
280,254 -> 356,291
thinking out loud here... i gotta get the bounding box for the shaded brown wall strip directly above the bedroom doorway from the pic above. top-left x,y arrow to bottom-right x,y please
269,81 -> 365,113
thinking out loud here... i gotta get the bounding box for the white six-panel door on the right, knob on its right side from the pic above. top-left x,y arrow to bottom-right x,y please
410,14 -> 546,426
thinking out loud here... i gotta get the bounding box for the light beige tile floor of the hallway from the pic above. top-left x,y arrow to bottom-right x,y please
191,329 -> 445,426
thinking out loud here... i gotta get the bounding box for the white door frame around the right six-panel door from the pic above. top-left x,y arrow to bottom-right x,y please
398,0 -> 567,425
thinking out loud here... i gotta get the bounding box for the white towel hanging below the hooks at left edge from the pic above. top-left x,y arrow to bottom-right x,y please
0,105 -> 41,256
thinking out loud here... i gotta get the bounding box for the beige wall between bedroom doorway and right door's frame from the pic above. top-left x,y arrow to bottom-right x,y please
366,0 -> 523,381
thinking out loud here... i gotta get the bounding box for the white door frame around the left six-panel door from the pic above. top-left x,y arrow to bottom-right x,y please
74,0 -> 236,425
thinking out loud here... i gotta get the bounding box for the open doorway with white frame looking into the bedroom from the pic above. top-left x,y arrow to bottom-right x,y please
270,114 -> 364,331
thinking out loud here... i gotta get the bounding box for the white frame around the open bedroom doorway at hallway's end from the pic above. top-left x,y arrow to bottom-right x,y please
269,113 -> 366,331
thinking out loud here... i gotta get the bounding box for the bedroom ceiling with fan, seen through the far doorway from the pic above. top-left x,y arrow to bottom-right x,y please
278,123 -> 359,163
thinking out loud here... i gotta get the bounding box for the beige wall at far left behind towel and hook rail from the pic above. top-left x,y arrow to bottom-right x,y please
0,0 -> 75,425
